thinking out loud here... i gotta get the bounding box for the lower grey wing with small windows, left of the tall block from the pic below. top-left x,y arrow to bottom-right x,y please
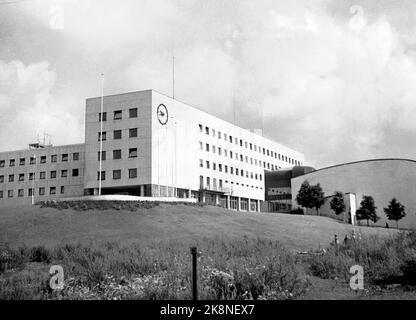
0,144 -> 85,206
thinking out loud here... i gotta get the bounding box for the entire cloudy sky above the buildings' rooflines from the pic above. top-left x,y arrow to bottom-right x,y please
0,0 -> 416,168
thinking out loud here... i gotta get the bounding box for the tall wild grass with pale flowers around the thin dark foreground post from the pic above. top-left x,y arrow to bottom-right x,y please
0,238 -> 307,299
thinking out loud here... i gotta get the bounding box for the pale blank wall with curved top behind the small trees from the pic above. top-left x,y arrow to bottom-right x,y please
292,159 -> 416,229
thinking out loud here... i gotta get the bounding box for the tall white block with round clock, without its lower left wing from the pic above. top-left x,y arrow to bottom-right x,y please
84,90 -> 304,211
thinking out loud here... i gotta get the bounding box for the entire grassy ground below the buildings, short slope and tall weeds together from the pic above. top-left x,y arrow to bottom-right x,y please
0,202 -> 416,300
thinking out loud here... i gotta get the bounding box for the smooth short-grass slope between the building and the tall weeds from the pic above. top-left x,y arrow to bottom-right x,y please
0,203 -> 395,250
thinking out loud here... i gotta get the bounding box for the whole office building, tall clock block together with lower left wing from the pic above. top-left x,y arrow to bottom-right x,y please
0,90 -> 304,211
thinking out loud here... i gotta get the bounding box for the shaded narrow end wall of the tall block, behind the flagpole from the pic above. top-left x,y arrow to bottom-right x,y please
84,90 -> 152,188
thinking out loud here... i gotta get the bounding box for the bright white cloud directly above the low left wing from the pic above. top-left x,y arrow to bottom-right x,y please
0,60 -> 84,151
